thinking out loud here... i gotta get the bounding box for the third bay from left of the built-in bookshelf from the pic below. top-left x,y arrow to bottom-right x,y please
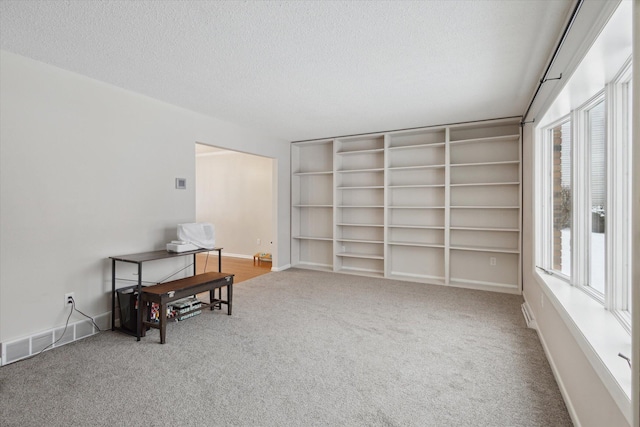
386,128 -> 447,284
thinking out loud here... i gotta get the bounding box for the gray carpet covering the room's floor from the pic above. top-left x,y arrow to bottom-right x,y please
0,269 -> 571,426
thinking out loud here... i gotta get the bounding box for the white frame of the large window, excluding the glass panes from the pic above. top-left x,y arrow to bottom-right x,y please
535,58 -> 632,333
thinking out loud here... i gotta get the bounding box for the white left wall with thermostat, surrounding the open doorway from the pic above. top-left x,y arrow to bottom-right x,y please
0,51 -> 290,342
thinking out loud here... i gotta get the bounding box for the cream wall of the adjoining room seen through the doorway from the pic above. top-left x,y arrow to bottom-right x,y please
196,150 -> 273,257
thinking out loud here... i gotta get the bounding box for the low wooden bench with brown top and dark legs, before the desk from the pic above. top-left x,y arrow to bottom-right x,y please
138,272 -> 233,344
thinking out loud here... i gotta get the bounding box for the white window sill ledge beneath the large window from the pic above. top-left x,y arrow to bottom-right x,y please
534,270 -> 631,420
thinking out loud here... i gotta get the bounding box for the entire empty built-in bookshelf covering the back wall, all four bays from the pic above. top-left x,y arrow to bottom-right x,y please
292,119 -> 521,293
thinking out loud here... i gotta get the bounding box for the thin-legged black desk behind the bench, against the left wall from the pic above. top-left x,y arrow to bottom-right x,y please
109,248 -> 222,341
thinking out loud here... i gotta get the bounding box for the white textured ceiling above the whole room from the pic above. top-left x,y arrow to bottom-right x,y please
0,0 -> 573,140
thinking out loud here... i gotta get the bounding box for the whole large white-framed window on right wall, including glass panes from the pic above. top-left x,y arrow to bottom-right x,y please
538,64 -> 633,330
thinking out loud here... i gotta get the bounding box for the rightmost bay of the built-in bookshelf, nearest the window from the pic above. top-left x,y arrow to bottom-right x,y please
449,123 -> 521,290
